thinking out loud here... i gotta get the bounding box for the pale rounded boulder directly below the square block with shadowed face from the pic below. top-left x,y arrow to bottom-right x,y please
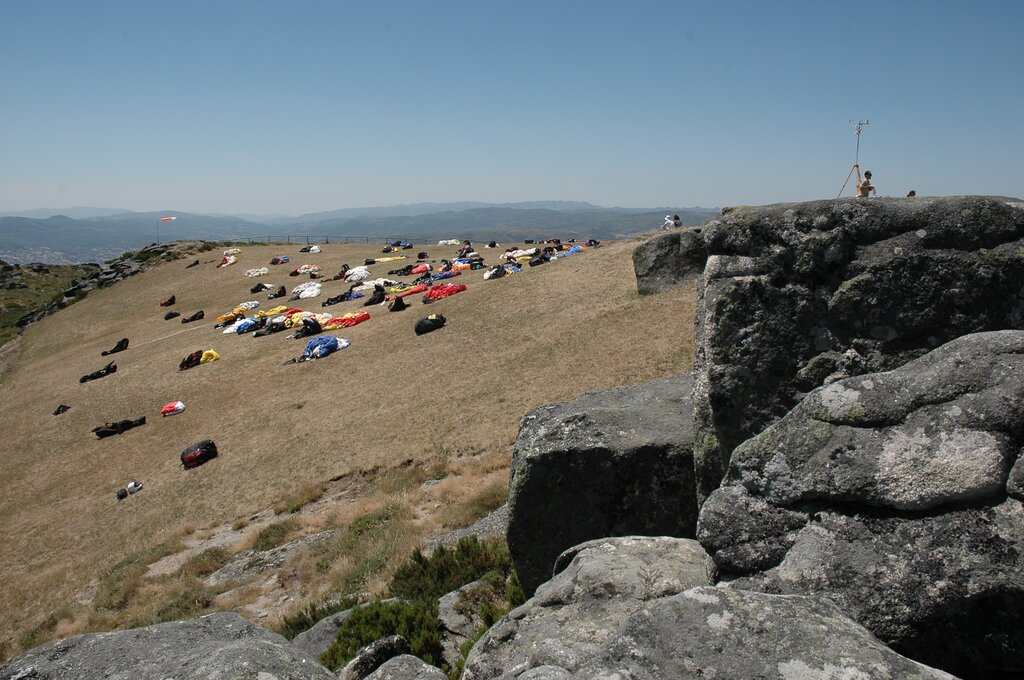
462,537 -> 712,680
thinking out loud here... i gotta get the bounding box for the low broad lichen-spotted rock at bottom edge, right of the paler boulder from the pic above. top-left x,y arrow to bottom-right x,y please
573,587 -> 953,680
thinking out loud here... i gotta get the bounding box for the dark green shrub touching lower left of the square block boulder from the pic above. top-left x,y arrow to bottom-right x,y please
389,536 -> 512,598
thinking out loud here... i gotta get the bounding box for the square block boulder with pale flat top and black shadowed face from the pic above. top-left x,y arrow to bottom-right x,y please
507,374 -> 697,596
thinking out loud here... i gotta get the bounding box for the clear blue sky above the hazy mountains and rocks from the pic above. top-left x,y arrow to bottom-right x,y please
0,0 -> 1024,214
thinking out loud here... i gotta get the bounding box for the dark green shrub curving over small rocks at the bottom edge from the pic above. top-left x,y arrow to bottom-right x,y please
321,599 -> 444,671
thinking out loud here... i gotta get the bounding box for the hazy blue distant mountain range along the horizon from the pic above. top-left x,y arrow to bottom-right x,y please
0,201 -> 718,263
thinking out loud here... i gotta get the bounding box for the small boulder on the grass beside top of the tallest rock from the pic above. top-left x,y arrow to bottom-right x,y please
633,228 -> 708,295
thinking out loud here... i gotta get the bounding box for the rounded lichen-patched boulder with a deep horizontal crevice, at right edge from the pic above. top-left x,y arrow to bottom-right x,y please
698,331 -> 1024,678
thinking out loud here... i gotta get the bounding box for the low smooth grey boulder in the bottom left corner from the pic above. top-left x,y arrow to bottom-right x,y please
0,613 -> 336,680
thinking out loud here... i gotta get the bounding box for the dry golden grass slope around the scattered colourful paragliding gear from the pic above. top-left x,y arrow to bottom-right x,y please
0,236 -> 694,656
